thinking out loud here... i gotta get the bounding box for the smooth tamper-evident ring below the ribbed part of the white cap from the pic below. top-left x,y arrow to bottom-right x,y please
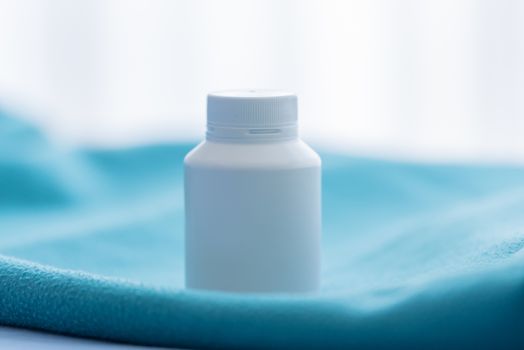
206,123 -> 298,143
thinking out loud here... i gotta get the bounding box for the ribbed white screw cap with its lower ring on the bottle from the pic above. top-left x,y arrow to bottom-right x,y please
206,90 -> 298,143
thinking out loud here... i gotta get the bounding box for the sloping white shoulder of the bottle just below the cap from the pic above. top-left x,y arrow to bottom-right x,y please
184,139 -> 321,169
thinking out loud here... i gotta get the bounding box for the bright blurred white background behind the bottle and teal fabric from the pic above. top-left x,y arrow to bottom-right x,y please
0,0 -> 524,162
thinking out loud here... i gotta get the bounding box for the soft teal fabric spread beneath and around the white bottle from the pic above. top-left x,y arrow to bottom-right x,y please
0,113 -> 524,349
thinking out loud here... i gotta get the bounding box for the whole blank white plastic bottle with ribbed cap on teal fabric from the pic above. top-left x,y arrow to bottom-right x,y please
184,90 -> 321,293
